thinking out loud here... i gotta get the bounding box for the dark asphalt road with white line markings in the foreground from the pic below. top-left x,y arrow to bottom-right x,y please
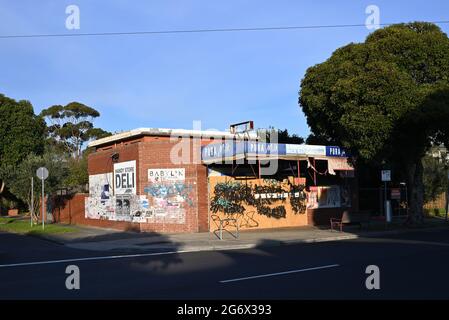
0,230 -> 449,299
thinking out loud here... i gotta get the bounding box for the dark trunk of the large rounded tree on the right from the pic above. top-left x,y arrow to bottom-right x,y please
407,159 -> 424,223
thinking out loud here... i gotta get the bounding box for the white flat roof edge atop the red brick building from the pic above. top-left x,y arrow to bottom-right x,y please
88,128 -> 257,147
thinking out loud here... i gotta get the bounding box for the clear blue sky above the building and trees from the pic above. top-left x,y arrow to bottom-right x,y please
0,0 -> 449,136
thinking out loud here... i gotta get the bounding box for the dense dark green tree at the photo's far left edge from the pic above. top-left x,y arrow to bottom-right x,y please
0,94 -> 45,193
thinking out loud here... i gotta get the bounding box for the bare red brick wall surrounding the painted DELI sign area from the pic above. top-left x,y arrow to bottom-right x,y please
78,136 -> 208,233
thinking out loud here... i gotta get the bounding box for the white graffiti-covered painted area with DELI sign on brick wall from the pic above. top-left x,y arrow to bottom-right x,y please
85,166 -> 194,223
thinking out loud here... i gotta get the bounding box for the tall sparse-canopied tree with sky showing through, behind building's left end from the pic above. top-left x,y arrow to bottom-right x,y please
41,102 -> 110,159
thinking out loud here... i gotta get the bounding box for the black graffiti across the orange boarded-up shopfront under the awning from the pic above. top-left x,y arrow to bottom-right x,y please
210,179 -> 306,220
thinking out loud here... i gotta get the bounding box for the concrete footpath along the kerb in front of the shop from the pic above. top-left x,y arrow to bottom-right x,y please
41,223 -> 449,252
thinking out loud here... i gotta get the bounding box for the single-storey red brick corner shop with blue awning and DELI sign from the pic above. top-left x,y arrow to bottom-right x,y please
53,128 -> 358,233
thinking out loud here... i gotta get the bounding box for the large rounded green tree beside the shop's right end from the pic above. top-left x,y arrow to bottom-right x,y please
299,22 -> 449,220
